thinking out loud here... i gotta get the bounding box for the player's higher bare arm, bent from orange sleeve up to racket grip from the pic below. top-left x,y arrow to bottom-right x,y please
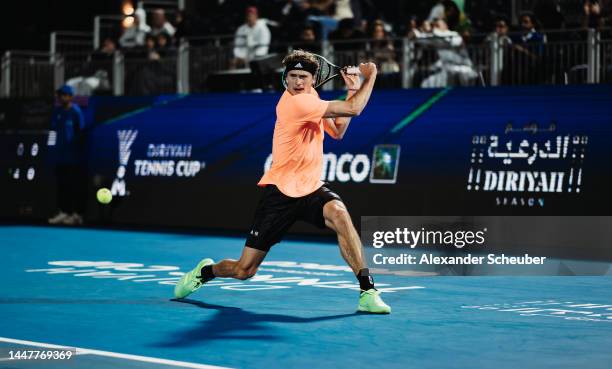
323,63 -> 377,118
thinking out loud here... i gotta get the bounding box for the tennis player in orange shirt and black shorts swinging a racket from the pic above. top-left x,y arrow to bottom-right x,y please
174,50 -> 391,314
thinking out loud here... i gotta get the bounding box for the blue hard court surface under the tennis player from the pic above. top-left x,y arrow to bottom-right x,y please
0,226 -> 612,369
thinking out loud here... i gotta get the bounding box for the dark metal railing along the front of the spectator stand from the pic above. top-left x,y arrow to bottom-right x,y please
2,30 -> 612,96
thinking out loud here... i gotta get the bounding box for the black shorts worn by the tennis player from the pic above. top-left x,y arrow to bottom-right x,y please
246,185 -> 342,252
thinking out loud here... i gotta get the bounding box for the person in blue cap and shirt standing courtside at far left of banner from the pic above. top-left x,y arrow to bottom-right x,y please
49,85 -> 86,225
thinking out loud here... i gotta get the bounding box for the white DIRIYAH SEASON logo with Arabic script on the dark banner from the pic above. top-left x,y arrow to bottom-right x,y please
467,133 -> 589,207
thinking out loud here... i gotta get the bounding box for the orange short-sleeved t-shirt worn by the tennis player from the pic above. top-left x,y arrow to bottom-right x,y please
258,89 -> 329,197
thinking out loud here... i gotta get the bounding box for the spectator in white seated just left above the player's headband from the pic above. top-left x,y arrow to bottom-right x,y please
230,6 -> 271,68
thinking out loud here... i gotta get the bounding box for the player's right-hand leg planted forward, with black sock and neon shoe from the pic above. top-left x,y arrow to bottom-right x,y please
323,200 -> 391,314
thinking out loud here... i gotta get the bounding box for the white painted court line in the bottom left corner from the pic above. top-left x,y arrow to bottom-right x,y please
0,337 -> 231,369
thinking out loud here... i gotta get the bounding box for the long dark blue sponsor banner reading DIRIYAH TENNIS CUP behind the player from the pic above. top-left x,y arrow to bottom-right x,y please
88,86 -> 612,234
